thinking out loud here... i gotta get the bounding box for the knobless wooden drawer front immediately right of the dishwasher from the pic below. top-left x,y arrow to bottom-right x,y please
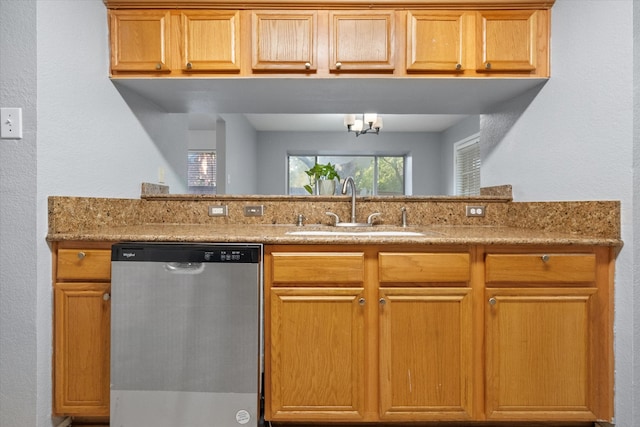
271,252 -> 364,286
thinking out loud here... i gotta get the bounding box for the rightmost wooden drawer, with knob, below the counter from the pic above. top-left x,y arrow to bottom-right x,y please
485,253 -> 596,283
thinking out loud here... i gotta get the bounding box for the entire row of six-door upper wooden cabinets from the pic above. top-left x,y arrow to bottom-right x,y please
107,0 -> 553,78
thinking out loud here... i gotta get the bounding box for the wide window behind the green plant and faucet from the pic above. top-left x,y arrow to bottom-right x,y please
287,154 -> 406,196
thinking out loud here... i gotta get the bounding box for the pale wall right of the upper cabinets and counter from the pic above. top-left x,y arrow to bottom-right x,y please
481,0 -> 640,427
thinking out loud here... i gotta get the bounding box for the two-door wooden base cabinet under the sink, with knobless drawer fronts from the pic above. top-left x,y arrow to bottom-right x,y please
265,246 -> 475,422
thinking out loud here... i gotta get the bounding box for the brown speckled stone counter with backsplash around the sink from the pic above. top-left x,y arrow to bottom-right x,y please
47,194 -> 622,247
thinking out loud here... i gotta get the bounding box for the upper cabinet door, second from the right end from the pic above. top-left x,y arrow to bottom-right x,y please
407,11 -> 472,73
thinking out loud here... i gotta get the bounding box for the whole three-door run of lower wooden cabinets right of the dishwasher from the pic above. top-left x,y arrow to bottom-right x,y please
265,245 -> 615,425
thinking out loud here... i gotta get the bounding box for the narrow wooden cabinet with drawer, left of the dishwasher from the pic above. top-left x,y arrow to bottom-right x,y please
53,243 -> 111,417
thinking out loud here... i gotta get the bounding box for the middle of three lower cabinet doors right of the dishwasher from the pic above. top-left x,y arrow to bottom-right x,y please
379,288 -> 474,421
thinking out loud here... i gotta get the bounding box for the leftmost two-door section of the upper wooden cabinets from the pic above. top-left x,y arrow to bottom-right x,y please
109,10 -> 240,76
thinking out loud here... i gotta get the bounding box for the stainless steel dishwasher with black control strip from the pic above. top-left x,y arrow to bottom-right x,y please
110,243 -> 262,427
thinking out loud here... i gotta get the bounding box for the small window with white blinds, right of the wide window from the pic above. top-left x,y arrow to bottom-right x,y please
454,136 -> 480,196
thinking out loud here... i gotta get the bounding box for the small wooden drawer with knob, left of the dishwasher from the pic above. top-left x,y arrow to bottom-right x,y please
56,249 -> 111,280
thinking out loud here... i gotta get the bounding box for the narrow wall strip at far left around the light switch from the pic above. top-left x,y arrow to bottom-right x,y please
0,0 -> 37,427
